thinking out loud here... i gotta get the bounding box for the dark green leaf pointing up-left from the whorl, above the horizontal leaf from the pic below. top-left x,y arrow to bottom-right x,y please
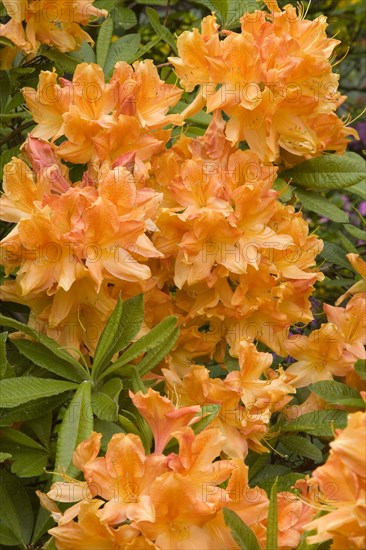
12,339 -> 86,382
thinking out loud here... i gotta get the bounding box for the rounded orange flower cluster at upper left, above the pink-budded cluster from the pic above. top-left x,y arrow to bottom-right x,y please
22,60 -> 182,164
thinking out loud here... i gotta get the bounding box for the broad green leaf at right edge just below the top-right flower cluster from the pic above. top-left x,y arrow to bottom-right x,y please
281,153 -> 366,191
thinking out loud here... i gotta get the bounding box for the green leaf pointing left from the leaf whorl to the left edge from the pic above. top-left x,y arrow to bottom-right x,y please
0,376 -> 77,409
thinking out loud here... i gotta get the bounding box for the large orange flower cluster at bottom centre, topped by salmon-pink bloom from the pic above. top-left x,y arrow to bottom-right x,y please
39,389 -> 314,550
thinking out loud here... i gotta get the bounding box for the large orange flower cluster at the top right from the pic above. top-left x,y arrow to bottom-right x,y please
170,0 -> 356,165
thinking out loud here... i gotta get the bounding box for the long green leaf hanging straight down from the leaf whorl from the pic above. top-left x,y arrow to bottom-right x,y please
55,382 -> 93,481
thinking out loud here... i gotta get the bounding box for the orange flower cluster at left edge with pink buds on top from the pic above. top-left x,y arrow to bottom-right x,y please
0,137 -> 162,352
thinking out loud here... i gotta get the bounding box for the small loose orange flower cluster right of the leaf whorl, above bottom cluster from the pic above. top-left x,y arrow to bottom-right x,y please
162,341 -> 295,458
